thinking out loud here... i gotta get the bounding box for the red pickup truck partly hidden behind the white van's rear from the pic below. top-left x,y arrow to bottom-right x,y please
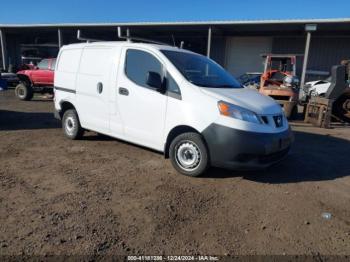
15,58 -> 56,101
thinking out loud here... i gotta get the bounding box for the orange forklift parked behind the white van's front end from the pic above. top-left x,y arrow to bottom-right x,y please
259,54 -> 300,119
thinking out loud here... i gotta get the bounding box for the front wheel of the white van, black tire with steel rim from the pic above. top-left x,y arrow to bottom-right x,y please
169,132 -> 209,177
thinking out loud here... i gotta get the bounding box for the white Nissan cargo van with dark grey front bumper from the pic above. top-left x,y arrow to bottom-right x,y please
54,41 -> 292,176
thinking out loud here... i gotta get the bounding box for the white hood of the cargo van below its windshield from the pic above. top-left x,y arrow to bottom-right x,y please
201,87 -> 282,115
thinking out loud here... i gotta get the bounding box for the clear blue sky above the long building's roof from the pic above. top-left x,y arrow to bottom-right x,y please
0,0 -> 350,23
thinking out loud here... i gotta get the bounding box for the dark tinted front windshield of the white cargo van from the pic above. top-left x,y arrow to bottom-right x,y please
161,50 -> 243,88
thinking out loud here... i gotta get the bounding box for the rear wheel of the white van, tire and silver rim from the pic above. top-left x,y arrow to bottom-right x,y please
62,109 -> 84,140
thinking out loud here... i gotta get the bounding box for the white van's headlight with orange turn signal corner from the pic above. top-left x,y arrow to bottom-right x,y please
218,101 -> 262,124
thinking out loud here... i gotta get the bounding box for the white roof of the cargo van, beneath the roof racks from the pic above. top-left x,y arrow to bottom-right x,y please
62,41 -> 192,53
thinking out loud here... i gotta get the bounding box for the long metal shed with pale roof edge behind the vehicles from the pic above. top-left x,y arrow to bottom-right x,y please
0,19 -> 350,82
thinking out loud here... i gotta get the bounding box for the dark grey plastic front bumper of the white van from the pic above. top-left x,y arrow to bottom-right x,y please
202,124 -> 294,170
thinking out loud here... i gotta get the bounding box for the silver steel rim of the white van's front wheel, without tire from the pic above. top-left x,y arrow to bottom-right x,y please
175,141 -> 201,171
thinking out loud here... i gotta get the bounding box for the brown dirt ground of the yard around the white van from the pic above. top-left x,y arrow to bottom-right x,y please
0,91 -> 350,255
